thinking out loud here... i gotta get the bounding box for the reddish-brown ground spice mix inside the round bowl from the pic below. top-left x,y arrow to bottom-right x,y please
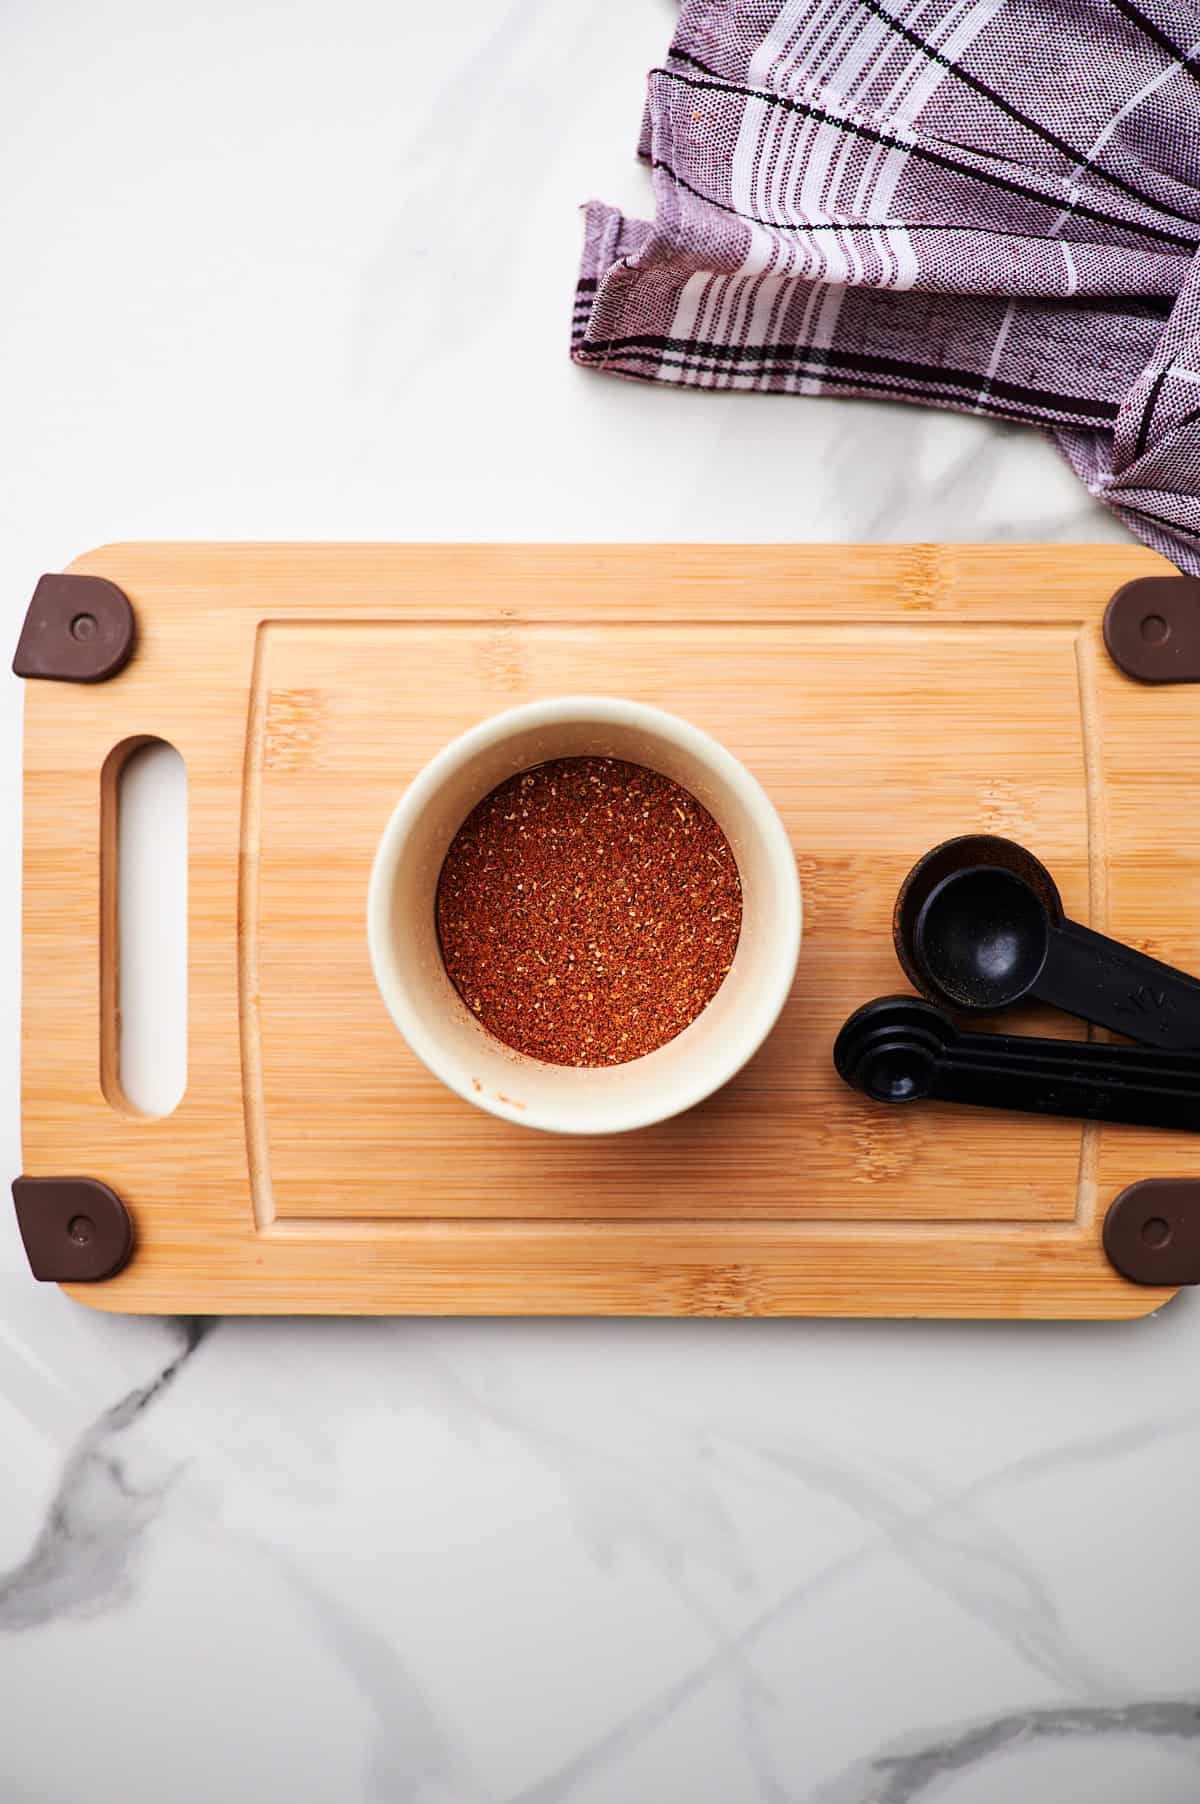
437,758 -> 742,1064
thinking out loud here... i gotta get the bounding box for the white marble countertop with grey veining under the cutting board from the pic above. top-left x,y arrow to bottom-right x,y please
0,0 -> 1200,1804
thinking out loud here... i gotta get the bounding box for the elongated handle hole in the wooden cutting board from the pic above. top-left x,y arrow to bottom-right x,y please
99,738 -> 188,1117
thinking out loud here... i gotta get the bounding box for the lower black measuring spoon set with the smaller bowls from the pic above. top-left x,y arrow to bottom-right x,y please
834,996 -> 1200,1133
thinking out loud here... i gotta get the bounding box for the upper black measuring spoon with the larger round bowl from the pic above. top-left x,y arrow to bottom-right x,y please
893,833 -> 1200,1052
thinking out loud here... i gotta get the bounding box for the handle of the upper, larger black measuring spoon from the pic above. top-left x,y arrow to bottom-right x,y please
1032,920 -> 1200,1052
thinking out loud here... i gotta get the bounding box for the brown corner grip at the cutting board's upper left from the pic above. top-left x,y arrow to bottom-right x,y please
13,575 -> 137,682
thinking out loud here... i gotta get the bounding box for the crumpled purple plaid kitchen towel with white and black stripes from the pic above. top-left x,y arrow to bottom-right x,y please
572,0 -> 1200,574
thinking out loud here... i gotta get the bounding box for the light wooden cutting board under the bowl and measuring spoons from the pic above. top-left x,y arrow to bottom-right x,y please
23,545 -> 1200,1317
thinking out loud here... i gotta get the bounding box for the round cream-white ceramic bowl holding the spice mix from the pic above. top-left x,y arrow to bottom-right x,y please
366,695 -> 801,1133
